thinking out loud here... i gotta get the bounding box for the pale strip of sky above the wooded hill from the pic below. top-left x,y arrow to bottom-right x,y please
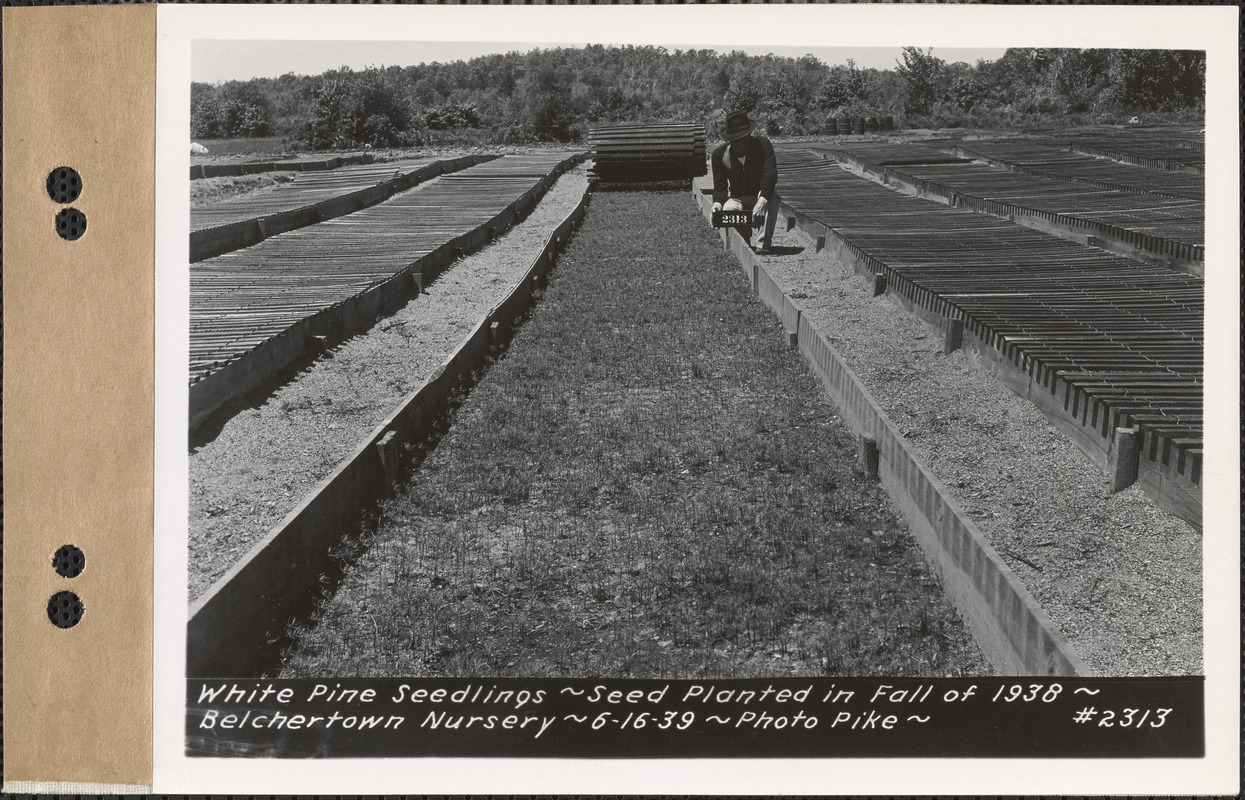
190,40 -> 1003,83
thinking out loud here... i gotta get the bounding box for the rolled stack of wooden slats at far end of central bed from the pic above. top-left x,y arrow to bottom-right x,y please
588,122 -> 706,184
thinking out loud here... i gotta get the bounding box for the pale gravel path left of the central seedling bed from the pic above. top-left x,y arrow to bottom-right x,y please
189,165 -> 588,600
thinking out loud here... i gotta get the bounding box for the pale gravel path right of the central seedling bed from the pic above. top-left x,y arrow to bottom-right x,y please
737,186 -> 1203,676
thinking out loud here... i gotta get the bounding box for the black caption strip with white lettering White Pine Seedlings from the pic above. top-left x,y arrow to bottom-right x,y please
186,677 -> 1205,758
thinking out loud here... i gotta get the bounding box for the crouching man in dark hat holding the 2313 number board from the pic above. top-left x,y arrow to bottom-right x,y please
712,111 -> 779,255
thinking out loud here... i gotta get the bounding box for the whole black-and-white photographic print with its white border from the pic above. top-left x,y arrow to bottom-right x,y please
157,6 -> 1239,793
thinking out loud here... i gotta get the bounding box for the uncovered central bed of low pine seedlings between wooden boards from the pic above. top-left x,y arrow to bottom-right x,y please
284,193 -> 990,678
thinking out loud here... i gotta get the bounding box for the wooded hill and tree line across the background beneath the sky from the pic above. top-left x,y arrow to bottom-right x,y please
190,45 -> 1206,149
